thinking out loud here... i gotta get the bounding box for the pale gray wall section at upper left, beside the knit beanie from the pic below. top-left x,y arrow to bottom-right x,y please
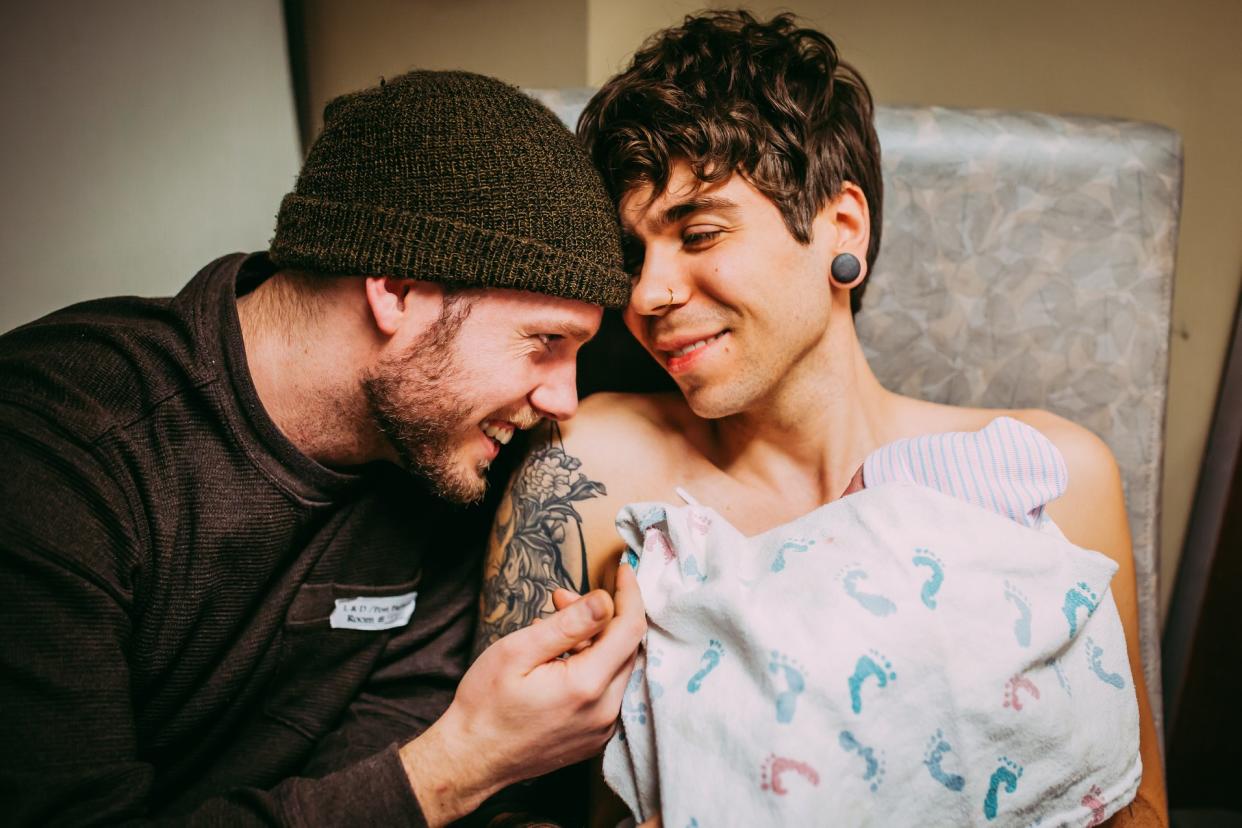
0,0 -> 301,331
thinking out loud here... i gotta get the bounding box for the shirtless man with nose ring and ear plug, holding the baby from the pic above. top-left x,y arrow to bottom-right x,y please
477,12 -> 1166,824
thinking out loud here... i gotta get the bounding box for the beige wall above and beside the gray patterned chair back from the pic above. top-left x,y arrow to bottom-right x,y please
308,0 -> 1242,620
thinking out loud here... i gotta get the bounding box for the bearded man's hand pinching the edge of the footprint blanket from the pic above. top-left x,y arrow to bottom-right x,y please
401,564 -> 646,826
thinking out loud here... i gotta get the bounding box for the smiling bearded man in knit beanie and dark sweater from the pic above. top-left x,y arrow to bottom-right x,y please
0,72 -> 643,826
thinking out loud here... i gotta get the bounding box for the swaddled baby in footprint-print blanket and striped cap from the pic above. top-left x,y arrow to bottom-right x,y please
605,418 -> 1141,828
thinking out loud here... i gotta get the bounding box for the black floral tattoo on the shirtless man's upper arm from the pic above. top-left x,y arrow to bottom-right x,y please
474,443 -> 607,655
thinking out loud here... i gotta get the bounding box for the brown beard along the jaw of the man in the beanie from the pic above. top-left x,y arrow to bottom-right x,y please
361,294 -> 488,503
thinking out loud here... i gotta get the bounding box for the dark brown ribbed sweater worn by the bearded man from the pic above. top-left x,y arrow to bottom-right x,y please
0,254 -> 478,826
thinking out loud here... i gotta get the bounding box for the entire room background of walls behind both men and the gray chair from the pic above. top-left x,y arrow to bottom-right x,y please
0,0 -> 1242,828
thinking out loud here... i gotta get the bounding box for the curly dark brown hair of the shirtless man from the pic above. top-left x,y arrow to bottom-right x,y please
578,11 -> 884,313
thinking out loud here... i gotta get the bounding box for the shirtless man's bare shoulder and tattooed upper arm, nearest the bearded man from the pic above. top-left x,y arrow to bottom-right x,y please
476,394 -> 690,652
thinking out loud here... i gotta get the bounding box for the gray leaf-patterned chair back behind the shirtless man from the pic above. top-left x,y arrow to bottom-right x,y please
530,89 -> 1181,732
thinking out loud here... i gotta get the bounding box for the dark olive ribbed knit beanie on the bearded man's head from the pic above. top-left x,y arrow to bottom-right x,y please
270,71 -> 630,308
